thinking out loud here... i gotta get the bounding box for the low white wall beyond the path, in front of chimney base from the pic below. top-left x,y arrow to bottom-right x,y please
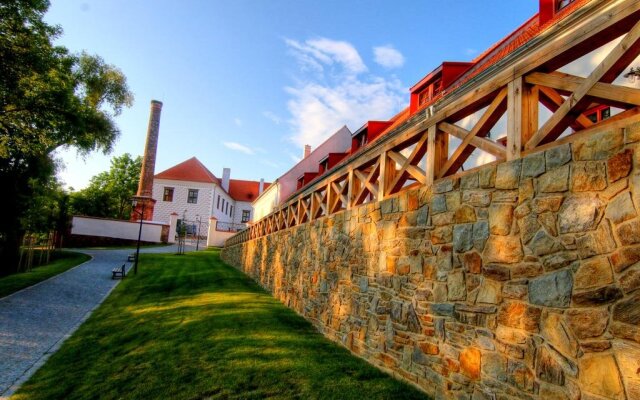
71,216 -> 169,243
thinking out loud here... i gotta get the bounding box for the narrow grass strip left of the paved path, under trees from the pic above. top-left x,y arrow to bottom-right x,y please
0,251 -> 91,298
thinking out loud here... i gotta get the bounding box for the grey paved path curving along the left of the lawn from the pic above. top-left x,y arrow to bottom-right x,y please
0,246 -> 190,399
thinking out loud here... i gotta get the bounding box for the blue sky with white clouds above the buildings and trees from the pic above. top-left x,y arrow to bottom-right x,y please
46,0 -> 538,189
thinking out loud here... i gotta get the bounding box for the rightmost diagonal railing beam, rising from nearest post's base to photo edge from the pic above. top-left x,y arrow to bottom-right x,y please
526,16 -> 640,149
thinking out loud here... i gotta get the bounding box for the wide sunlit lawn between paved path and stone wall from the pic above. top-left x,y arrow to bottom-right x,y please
13,250 -> 425,400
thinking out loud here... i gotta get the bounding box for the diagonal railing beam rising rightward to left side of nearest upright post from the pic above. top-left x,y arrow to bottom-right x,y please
438,88 -> 507,178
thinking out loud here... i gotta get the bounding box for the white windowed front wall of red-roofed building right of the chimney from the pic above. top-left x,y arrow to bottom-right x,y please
153,179 -> 215,224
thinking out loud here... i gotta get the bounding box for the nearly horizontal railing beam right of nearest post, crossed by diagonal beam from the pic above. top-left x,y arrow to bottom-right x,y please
525,72 -> 640,108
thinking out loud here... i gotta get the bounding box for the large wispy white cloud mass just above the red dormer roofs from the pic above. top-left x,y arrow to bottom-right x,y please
285,39 -> 407,148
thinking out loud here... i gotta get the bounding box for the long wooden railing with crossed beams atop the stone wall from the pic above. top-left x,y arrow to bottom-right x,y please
226,0 -> 640,246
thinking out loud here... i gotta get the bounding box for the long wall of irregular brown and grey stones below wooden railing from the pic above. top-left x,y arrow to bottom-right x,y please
223,124 -> 640,400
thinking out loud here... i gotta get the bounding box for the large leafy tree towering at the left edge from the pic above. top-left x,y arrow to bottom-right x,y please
0,0 -> 133,275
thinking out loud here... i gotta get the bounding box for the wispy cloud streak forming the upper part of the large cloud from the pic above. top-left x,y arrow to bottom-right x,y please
285,38 -> 367,74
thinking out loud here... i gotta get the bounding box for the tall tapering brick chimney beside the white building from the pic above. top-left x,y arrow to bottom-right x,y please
131,100 -> 162,221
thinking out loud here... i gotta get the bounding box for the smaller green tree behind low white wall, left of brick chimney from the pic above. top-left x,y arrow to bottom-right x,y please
71,153 -> 142,219
